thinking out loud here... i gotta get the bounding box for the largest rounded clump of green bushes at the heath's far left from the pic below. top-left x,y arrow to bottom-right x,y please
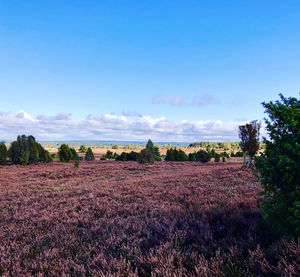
9,135 -> 52,165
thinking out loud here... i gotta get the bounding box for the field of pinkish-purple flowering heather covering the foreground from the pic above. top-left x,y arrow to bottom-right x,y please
0,161 -> 300,276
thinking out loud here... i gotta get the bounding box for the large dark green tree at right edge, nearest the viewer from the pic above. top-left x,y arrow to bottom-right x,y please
255,94 -> 300,236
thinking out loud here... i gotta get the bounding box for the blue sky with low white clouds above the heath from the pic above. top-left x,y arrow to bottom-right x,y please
0,0 -> 300,142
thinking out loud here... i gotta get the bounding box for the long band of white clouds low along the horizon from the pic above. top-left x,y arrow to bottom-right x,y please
0,111 -> 255,142
